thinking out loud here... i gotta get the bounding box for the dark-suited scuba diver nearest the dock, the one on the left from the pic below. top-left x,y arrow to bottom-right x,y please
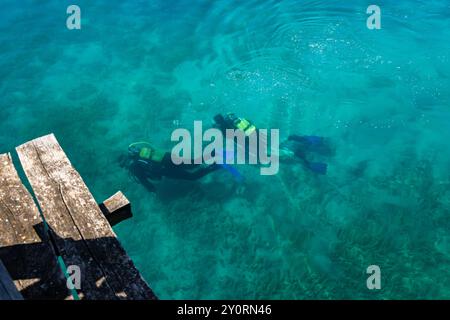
119,142 -> 221,191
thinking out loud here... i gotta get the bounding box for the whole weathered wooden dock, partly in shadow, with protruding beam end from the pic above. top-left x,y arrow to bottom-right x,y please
0,134 -> 157,300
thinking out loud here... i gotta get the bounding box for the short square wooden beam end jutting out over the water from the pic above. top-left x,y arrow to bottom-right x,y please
100,191 -> 133,226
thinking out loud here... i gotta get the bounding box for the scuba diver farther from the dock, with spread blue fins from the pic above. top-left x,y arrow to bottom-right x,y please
214,113 -> 331,175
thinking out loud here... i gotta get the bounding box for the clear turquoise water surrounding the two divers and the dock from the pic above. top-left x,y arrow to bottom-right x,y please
0,0 -> 450,299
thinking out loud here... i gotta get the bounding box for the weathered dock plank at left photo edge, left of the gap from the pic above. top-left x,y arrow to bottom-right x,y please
0,154 -> 68,299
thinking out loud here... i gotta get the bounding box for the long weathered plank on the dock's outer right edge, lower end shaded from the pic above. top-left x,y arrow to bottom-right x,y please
16,134 -> 156,299
